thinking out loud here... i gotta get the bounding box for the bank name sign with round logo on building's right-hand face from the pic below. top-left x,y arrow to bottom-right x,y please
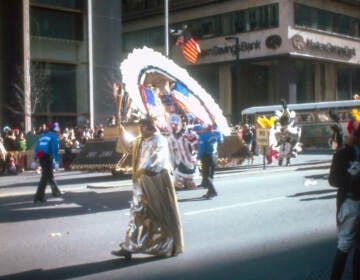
291,34 -> 356,59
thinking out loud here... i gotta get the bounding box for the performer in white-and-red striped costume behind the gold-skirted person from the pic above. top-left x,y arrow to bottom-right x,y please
168,115 -> 198,189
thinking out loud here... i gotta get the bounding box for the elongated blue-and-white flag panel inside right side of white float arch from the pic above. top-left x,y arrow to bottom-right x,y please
172,82 -> 213,124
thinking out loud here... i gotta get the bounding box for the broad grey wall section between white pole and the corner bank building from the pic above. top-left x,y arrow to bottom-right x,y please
91,0 -> 122,124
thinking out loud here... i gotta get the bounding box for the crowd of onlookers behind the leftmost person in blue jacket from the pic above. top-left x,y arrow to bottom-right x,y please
0,123 -> 104,175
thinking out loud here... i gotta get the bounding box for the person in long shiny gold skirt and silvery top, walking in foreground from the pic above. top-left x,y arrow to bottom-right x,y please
111,117 -> 183,259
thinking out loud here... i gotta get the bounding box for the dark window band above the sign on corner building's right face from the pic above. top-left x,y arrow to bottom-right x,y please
295,3 -> 360,38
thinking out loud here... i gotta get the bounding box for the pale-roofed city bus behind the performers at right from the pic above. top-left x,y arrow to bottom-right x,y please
241,100 -> 360,150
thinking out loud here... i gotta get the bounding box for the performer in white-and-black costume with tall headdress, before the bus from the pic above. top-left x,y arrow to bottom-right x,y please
275,100 -> 301,165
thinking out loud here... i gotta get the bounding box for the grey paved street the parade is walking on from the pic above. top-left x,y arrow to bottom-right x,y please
0,154 -> 350,280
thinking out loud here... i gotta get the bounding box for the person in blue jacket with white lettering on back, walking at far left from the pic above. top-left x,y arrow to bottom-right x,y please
34,122 -> 61,203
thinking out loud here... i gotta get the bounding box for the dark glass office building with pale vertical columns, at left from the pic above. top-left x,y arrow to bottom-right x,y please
0,0 -> 122,131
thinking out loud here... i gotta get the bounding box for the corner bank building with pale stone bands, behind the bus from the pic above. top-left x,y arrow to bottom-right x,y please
123,0 -> 360,122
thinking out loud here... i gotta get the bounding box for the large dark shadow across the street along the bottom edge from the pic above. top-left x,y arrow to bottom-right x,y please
0,236 -> 351,280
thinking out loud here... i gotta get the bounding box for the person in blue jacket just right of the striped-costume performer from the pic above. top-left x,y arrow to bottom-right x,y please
197,125 -> 224,199
